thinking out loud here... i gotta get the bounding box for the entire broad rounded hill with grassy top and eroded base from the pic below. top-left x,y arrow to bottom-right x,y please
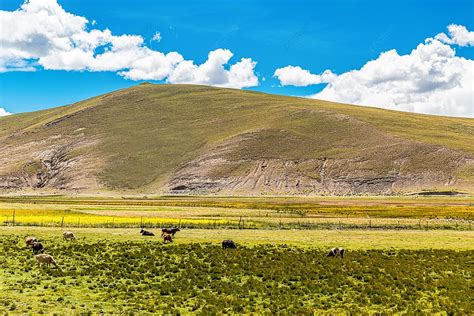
0,83 -> 474,195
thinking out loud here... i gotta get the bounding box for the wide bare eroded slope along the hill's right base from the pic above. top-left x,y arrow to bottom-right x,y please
168,129 -> 474,195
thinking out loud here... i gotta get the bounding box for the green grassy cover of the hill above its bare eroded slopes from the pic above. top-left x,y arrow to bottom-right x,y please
0,85 -> 474,194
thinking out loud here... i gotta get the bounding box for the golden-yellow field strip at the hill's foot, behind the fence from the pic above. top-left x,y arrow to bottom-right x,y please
0,196 -> 474,230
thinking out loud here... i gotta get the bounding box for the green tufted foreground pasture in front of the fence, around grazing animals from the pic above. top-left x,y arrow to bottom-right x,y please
0,228 -> 473,314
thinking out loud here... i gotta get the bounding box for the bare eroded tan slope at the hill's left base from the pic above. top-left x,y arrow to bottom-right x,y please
0,135 -> 100,193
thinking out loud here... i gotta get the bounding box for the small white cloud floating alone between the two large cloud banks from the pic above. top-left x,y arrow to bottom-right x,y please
273,66 -> 336,87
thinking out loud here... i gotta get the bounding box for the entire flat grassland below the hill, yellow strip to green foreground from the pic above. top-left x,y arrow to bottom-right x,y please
0,196 -> 474,315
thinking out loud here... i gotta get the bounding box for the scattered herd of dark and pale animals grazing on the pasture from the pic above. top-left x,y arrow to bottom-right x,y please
25,228 -> 344,267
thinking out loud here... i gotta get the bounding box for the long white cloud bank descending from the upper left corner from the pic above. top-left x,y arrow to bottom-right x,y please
0,0 -> 258,88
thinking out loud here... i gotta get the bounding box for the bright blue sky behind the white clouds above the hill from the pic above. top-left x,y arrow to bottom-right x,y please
0,0 -> 474,116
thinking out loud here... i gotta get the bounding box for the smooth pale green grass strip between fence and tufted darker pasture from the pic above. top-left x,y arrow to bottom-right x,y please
0,226 -> 474,251
